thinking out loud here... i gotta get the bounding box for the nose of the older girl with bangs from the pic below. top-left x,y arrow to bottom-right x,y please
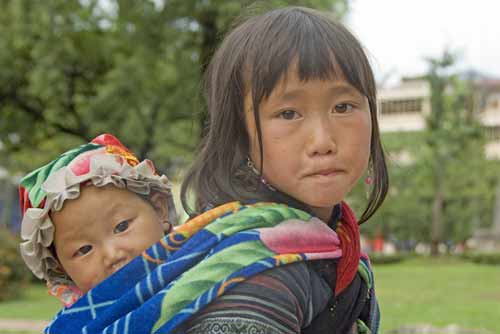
307,117 -> 337,156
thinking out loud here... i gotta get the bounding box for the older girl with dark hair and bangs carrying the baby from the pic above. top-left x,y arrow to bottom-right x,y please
181,7 -> 388,333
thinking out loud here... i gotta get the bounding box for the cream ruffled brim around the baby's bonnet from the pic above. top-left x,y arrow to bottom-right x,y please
20,154 -> 177,285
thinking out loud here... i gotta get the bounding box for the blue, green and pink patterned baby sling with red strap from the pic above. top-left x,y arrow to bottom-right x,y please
45,202 -> 376,333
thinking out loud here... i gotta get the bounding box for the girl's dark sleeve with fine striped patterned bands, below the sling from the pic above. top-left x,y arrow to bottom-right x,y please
175,260 -> 334,334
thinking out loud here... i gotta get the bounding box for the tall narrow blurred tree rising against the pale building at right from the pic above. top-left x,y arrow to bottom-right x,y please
425,51 -> 485,255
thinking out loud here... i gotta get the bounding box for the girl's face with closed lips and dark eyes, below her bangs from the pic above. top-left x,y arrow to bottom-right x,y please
245,67 -> 371,221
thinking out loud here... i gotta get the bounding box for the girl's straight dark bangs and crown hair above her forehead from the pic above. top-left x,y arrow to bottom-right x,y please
242,7 -> 375,103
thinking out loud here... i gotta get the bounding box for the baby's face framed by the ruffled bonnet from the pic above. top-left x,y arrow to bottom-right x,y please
51,185 -> 166,293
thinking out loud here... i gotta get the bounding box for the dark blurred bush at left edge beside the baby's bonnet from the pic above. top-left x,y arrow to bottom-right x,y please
0,228 -> 31,302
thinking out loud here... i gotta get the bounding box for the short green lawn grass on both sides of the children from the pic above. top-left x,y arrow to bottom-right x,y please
0,258 -> 500,334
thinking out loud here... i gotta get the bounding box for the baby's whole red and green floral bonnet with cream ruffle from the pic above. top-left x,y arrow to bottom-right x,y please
19,134 -> 176,305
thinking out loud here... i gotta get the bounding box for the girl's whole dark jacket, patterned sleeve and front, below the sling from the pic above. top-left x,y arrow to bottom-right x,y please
180,203 -> 379,334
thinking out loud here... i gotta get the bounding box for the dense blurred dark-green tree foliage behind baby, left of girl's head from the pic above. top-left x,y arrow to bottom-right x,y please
0,0 -> 348,172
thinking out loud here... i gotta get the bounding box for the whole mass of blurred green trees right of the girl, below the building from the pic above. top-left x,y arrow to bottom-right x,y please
352,52 -> 498,254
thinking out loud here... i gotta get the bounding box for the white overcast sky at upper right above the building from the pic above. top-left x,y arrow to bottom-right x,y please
347,0 -> 500,82
